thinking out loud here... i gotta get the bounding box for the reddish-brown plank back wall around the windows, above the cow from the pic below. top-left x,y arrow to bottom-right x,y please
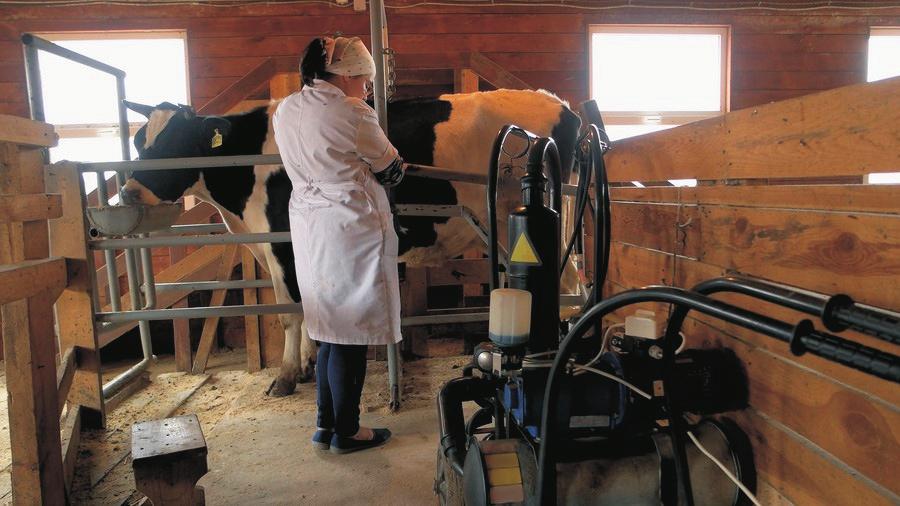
0,0 -> 900,115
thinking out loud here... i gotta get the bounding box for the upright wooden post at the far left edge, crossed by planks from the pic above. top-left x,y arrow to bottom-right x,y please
0,116 -> 66,504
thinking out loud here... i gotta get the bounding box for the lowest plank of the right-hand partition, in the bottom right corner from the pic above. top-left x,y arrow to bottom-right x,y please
728,410 -> 896,506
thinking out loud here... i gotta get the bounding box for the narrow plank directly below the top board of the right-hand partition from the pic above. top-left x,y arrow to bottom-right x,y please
610,185 -> 900,214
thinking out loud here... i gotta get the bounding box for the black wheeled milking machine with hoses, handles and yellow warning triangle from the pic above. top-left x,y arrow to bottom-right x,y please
435,111 -> 900,505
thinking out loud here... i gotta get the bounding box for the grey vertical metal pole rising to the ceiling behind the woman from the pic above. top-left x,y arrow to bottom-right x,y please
369,0 -> 400,411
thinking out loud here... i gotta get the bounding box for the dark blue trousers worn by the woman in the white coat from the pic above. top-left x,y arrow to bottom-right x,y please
316,343 -> 368,437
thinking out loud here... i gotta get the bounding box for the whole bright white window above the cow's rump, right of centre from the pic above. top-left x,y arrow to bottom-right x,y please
590,25 -> 729,186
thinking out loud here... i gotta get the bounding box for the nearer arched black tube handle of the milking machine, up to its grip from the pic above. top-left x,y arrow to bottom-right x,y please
537,286 -> 796,505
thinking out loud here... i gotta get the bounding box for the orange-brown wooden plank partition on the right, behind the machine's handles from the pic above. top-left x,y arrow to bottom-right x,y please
606,77 -> 900,505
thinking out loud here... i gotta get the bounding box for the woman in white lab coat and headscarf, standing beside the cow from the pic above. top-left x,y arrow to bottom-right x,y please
273,37 -> 403,453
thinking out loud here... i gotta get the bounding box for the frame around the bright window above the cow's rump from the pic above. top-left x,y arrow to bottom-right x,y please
588,23 -> 731,133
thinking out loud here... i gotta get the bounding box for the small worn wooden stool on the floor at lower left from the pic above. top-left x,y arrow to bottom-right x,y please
131,415 -> 208,506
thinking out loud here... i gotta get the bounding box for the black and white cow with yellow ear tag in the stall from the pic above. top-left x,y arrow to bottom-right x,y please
121,90 -> 581,396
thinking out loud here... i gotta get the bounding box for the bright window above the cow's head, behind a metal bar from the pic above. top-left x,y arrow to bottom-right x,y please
38,31 -> 190,191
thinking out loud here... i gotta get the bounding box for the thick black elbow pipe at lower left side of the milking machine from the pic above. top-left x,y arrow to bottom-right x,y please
437,377 -> 494,476
